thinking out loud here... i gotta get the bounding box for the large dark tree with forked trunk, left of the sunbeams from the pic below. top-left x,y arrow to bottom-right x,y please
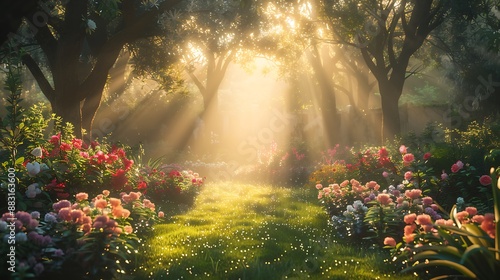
1,0 -> 181,139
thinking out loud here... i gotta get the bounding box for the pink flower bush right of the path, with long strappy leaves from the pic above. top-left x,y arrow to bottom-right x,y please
311,142 -> 500,279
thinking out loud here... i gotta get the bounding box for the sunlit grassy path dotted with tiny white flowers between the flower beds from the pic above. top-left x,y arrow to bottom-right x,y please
136,183 -> 409,279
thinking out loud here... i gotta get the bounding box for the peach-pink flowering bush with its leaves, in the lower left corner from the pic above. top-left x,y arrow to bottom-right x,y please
0,190 -> 157,279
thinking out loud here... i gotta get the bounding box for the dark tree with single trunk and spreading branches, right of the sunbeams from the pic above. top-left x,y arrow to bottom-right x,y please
321,0 -> 480,139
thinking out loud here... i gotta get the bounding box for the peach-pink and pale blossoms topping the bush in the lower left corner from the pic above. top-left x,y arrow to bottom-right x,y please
0,190 -> 160,276
